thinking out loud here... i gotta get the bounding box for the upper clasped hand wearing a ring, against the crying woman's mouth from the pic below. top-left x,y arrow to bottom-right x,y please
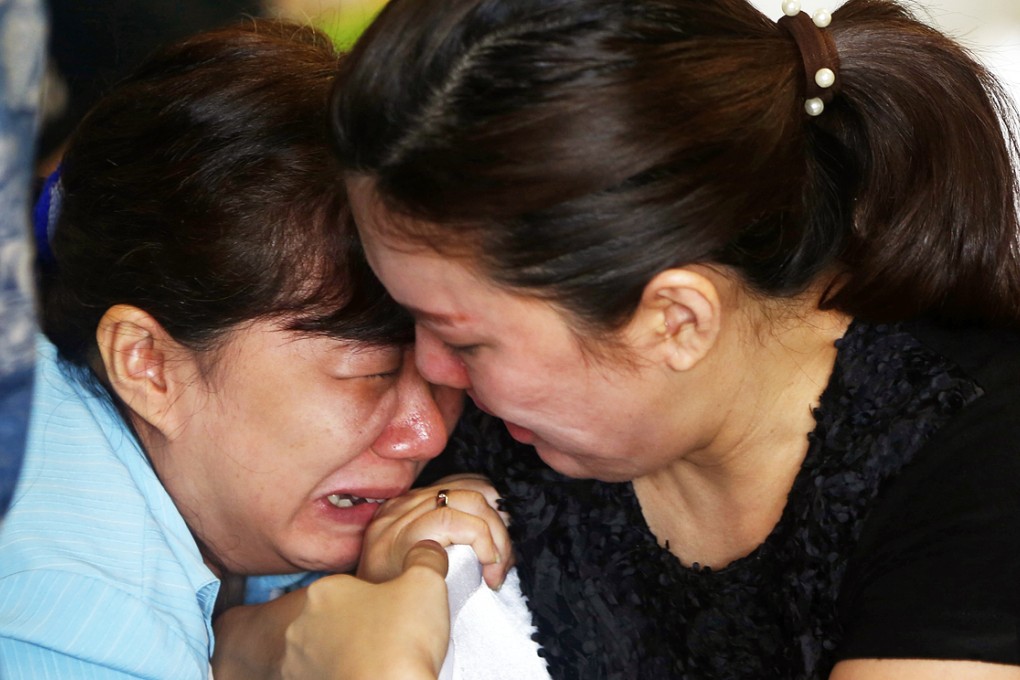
358,474 -> 513,588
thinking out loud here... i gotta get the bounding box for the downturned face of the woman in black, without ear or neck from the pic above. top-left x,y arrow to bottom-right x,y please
349,180 -> 676,480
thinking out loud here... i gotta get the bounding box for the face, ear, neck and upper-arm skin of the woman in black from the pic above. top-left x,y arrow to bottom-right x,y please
348,177 -> 1020,680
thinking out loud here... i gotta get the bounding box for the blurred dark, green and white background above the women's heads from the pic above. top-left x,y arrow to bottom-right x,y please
31,0 -> 1020,175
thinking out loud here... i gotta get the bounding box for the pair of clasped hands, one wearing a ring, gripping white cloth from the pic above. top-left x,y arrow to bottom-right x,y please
283,475 -> 513,680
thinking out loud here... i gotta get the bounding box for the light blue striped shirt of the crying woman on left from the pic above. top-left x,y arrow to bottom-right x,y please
0,339 -> 310,680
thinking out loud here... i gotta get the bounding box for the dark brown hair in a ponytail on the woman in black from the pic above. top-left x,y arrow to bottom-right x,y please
333,0 -> 1020,331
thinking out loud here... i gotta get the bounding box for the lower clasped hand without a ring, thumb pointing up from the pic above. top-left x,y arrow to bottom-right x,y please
283,540 -> 450,680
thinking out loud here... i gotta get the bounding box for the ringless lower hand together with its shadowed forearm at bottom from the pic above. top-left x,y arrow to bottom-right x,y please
212,540 -> 450,680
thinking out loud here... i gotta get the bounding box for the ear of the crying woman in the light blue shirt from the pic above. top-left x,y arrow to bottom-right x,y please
96,305 -> 190,434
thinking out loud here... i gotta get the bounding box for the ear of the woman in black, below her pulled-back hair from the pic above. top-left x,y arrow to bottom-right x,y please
630,268 -> 722,371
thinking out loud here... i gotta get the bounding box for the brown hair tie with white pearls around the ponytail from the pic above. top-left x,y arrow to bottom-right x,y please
778,0 -> 839,116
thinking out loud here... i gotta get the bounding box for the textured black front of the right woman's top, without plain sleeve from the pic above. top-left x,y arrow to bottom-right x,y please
455,322 -> 1015,680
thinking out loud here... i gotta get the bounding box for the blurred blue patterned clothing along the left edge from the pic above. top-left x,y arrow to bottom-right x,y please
0,0 -> 47,516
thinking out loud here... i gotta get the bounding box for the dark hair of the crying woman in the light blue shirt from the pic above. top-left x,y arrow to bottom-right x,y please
41,20 -> 411,375
